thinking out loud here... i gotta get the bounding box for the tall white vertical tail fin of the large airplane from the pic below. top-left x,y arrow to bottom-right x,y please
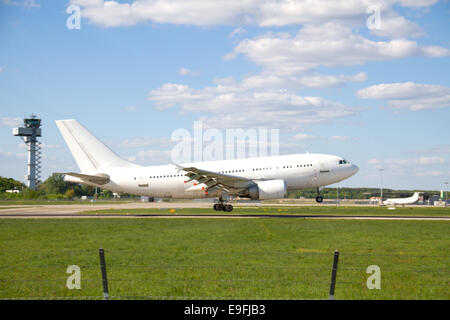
56,120 -> 138,172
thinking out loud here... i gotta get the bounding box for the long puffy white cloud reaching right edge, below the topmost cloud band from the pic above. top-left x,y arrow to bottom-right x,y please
227,22 -> 450,75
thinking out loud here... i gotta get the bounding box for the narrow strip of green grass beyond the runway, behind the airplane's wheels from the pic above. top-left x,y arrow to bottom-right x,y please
85,204 -> 450,217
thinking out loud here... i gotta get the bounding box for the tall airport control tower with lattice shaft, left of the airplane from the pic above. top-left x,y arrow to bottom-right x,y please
13,114 -> 41,190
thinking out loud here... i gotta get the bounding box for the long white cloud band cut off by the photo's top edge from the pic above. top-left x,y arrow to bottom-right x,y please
71,0 -> 435,27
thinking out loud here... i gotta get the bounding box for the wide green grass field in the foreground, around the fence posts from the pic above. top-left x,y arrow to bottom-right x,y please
0,219 -> 450,299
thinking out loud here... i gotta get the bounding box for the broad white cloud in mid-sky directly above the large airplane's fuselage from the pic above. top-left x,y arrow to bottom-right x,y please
148,82 -> 357,129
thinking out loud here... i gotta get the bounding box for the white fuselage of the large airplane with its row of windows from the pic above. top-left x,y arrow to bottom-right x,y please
82,154 -> 358,199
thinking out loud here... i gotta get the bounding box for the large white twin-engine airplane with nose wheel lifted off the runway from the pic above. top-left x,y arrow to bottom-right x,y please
56,120 -> 358,212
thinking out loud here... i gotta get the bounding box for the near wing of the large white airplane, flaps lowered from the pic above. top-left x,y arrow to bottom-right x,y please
174,164 -> 254,193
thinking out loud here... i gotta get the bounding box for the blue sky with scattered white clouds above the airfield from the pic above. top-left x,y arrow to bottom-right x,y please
0,0 -> 450,190
